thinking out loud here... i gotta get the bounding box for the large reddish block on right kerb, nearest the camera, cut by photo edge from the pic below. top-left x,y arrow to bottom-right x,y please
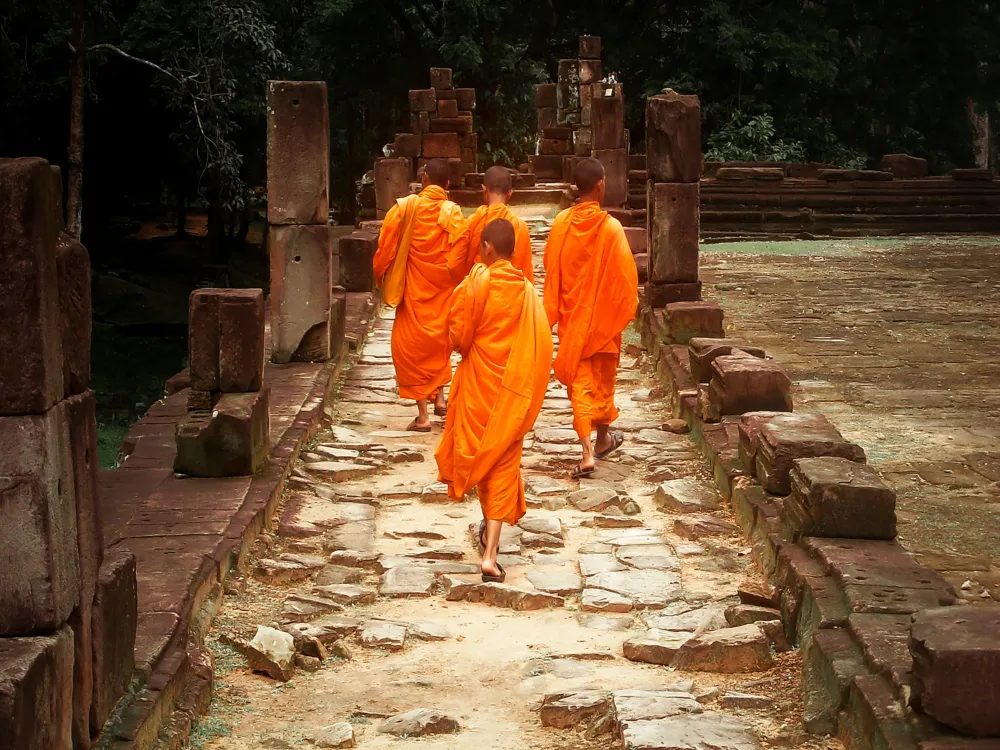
910,605 -> 1000,737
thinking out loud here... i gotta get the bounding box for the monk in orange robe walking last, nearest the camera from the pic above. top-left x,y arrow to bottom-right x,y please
434,219 -> 552,583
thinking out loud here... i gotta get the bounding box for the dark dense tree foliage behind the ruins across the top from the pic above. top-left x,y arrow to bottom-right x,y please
0,0 -> 1000,238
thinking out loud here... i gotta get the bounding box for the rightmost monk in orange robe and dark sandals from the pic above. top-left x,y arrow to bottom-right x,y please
545,159 -> 639,478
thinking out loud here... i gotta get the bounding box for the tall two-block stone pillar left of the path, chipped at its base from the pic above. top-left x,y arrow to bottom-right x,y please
267,81 -> 333,364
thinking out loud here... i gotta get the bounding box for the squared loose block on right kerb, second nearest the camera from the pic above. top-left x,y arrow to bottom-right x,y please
783,456 -> 896,539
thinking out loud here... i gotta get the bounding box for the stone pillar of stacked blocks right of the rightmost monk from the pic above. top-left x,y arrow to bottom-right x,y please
646,89 -> 701,308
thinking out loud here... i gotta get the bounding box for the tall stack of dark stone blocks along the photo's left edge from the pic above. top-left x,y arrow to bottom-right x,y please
0,159 -> 137,750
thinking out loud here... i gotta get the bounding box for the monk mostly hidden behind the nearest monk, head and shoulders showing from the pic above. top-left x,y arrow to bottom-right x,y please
450,166 -> 535,284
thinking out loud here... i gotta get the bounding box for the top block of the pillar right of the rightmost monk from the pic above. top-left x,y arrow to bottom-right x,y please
646,91 -> 701,183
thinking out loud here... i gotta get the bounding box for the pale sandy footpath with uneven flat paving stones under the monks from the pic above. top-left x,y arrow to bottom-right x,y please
194,217 -> 836,750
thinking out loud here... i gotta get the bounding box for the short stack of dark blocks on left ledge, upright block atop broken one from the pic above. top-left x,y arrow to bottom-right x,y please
174,289 -> 272,477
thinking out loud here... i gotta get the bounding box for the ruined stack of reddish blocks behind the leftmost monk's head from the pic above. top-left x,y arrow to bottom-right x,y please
375,68 -> 479,206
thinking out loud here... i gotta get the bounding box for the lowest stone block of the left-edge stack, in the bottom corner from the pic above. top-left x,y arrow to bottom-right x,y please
0,627 -> 73,750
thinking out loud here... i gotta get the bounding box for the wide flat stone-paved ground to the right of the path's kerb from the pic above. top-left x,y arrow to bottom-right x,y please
702,238 -> 1000,598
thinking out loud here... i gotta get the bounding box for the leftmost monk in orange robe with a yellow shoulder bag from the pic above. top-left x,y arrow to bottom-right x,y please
374,159 -> 465,432
